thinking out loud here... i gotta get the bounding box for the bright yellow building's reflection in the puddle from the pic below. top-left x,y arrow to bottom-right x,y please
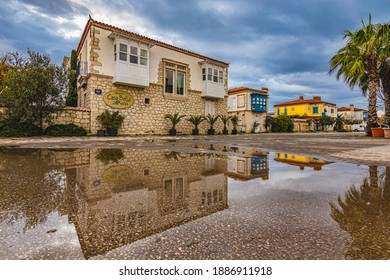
274,153 -> 329,170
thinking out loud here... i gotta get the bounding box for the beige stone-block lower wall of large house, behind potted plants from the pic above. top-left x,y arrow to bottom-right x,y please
79,74 -> 227,135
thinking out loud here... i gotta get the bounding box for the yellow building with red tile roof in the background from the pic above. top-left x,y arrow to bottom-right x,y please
274,96 -> 337,118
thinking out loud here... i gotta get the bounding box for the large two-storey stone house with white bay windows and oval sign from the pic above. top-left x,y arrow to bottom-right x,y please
77,18 -> 229,135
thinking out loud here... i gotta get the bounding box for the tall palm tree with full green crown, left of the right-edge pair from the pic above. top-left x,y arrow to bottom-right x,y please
329,15 -> 384,135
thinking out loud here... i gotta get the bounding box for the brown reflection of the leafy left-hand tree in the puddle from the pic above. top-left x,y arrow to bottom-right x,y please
0,148 -> 66,232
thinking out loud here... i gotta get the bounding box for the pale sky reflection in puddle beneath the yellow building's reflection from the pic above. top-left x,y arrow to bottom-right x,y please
229,153 -> 368,199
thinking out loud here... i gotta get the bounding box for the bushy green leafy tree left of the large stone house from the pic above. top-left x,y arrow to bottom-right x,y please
3,50 -> 66,128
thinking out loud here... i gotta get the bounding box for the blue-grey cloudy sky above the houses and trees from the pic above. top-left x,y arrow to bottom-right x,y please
0,0 -> 390,110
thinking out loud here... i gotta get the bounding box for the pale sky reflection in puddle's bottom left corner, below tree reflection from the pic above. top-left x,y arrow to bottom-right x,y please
0,213 -> 83,259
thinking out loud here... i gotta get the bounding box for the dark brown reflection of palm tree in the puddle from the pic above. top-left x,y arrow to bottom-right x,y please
330,166 -> 390,259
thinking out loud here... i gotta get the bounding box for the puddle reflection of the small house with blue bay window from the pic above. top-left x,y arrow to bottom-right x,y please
227,153 -> 269,181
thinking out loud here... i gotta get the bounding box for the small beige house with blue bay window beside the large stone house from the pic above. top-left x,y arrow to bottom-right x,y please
228,87 -> 268,133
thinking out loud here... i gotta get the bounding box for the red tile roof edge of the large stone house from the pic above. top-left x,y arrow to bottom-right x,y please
77,16 -> 229,67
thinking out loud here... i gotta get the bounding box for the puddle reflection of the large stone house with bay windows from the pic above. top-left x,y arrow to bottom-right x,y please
71,150 -> 227,258
